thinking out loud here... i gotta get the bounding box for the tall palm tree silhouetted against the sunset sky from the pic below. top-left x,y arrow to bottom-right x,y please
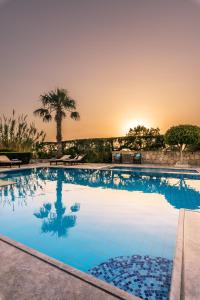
34,88 -> 80,157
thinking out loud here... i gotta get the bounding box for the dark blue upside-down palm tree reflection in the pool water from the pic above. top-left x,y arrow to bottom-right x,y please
34,172 -> 80,237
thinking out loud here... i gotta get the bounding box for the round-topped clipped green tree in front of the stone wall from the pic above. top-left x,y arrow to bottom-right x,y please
165,125 -> 200,162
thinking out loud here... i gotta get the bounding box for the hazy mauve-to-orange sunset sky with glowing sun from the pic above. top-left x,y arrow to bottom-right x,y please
0,0 -> 200,141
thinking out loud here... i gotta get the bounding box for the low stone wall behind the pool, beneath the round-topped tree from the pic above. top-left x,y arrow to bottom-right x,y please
112,151 -> 200,166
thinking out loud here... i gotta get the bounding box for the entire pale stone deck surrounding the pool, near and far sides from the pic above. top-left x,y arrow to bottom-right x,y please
0,163 -> 200,300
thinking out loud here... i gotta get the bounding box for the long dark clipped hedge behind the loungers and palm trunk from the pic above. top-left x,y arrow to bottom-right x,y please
37,135 -> 164,163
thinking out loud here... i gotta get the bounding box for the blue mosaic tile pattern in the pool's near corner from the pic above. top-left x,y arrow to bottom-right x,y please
89,255 -> 172,300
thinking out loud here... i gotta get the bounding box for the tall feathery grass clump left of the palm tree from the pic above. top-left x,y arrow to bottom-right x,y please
0,110 -> 45,152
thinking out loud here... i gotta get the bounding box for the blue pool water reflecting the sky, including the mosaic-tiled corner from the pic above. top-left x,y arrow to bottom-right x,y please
0,168 -> 200,300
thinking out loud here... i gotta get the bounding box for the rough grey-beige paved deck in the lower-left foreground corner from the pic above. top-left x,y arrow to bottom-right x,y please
0,236 -> 139,300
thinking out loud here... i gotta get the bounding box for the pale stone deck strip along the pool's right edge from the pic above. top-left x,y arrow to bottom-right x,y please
170,210 -> 200,300
